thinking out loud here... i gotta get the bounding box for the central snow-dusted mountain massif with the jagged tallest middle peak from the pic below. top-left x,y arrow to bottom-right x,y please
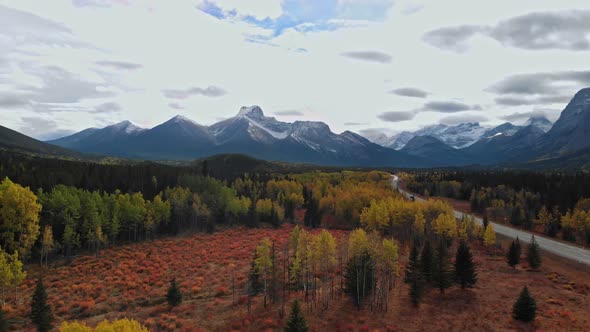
52,106 -> 430,167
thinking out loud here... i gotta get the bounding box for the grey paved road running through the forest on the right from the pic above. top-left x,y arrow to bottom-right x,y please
391,175 -> 590,266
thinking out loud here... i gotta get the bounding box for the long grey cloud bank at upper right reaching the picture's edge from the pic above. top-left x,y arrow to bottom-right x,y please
423,10 -> 590,52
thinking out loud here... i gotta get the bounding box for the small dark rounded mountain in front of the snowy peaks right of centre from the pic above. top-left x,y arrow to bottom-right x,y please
400,136 -> 471,166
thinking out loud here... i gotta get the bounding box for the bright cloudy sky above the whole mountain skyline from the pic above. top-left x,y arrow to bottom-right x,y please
0,0 -> 590,140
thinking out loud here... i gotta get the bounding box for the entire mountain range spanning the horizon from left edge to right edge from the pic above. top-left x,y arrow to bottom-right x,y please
0,88 -> 590,168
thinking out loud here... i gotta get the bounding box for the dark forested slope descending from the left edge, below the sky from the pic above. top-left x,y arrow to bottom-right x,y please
0,126 -> 88,159
